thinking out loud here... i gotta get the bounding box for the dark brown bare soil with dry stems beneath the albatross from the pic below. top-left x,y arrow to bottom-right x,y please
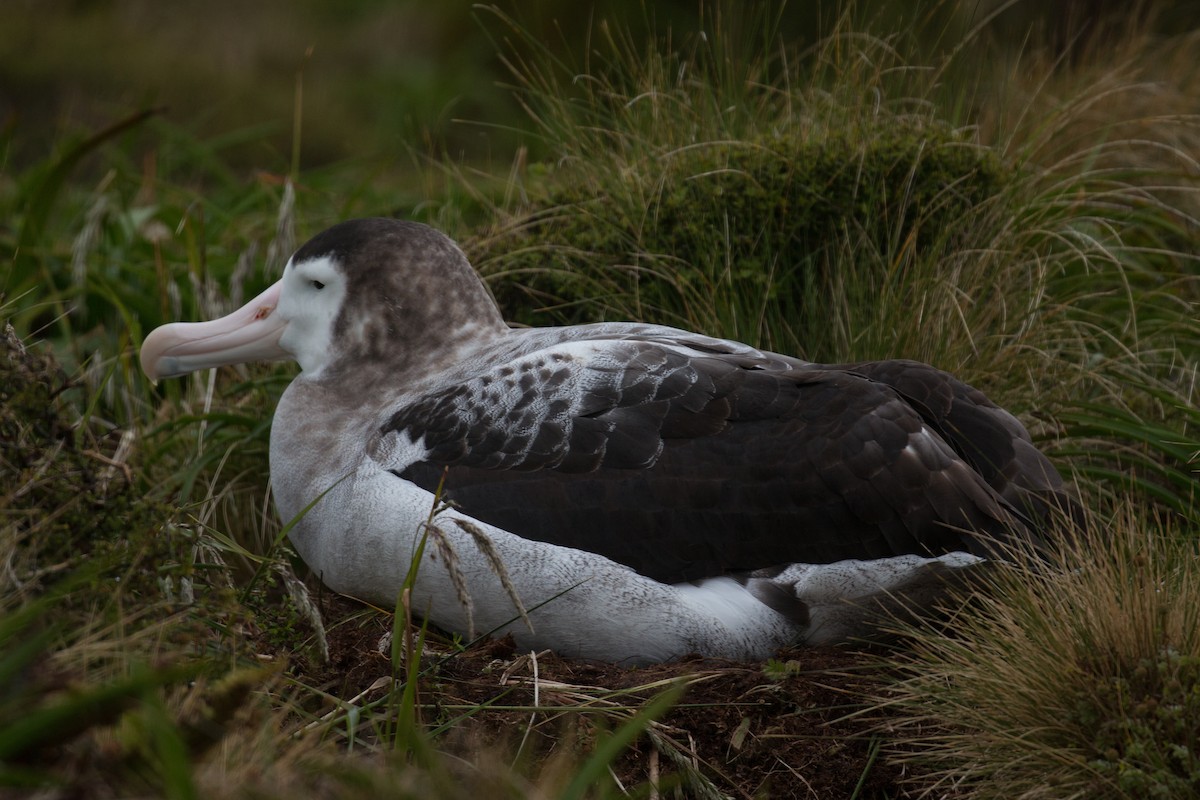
295,595 -> 940,800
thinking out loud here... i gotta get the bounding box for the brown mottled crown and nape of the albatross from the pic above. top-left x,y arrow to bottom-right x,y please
293,217 -> 506,379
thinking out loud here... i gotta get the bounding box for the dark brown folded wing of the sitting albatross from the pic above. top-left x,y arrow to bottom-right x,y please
385,342 -> 1057,582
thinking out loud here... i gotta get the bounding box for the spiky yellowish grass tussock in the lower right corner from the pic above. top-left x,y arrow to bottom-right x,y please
883,512 -> 1200,799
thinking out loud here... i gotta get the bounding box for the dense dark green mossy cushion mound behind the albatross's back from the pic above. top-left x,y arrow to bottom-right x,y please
487,119 -> 1012,357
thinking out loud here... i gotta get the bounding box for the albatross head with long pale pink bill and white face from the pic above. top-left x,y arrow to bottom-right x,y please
142,218 -> 506,380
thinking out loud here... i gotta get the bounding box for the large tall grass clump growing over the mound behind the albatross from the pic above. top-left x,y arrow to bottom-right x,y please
468,8 -> 1018,368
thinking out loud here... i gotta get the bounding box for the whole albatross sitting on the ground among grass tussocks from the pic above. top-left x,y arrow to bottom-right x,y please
142,218 -> 1073,663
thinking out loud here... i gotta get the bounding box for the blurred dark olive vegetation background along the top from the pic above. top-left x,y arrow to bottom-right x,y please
9,0 -> 1200,174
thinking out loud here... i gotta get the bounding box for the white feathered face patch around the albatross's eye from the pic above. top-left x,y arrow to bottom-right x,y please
275,255 -> 346,377
